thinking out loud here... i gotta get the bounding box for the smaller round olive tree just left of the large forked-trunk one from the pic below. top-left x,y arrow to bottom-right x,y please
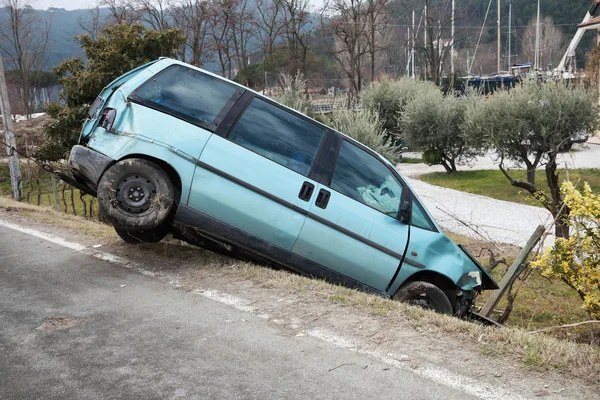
402,90 -> 480,174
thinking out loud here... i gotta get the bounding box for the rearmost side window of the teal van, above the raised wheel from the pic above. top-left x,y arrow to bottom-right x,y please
129,65 -> 237,126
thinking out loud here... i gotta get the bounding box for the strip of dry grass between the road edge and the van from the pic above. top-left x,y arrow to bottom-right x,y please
0,199 -> 600,384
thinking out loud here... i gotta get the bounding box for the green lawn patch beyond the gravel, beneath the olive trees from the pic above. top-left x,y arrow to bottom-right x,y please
420,169 -> 600,206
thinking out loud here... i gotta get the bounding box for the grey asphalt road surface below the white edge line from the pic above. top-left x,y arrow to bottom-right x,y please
0,227 -> 478,400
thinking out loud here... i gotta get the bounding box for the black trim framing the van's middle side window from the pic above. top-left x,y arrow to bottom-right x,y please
220,91 -> 331,178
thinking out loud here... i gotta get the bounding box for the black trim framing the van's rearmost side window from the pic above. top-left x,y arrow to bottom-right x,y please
127,64 -> 247,132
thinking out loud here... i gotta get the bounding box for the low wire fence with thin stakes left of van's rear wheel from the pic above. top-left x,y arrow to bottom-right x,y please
0,160 -> 98,219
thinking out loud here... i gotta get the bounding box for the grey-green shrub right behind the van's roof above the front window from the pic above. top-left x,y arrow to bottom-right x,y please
324,109 -> 402,163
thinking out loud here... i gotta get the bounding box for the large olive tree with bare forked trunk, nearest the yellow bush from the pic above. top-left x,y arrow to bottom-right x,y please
464,80 -> 598,237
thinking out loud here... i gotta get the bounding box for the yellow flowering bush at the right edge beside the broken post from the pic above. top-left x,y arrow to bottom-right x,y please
532,182 -> 600,318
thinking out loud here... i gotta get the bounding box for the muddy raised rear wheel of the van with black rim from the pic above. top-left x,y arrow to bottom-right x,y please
98,158 -> 175,232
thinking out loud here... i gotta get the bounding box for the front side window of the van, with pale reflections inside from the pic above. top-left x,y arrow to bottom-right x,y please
330,140 -> 402,218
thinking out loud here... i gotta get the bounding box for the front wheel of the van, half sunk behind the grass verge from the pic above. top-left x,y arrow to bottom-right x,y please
394,281 -> 452,315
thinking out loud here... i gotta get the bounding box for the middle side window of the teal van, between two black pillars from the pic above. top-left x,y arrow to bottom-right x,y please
229,98 -> 325,175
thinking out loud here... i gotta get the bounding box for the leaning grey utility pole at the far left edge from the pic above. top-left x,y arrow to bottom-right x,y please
0,56 -> 23,201
